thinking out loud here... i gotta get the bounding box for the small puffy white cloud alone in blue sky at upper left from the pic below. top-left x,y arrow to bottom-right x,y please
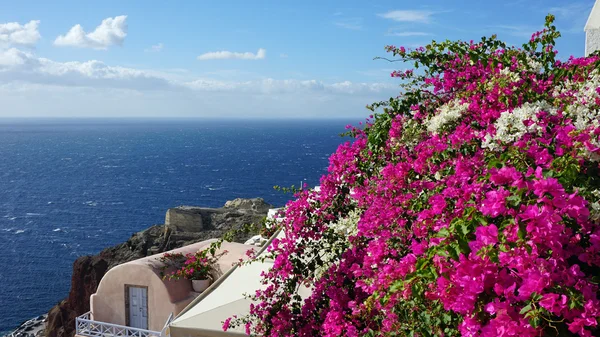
54,15 -> 127,49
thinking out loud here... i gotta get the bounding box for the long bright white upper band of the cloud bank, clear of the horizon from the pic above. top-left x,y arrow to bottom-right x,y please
0,48 -> 397,95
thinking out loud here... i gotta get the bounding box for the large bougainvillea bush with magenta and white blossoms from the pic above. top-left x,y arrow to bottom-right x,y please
224,16 -> 600,336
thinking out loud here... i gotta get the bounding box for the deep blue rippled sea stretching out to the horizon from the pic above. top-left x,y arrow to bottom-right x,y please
0,120 -> 348,336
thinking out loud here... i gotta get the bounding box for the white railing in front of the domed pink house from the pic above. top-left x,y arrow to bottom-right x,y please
75,311 -> 166,337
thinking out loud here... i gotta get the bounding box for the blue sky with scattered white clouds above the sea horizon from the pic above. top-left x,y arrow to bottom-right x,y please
0,0 -> 594,118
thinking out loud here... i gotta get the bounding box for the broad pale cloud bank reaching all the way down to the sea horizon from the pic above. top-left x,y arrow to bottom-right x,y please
0,48 -> 399,118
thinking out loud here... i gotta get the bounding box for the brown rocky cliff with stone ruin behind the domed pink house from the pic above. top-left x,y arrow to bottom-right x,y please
45,198 -> 273,337
